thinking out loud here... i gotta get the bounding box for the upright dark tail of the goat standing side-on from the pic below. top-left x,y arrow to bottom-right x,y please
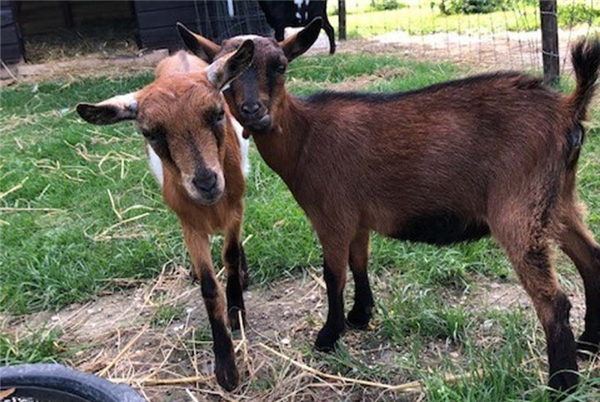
569,37 -> 600,122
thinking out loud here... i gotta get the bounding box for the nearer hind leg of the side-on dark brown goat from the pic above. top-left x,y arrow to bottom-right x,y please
490,213 -> 578,391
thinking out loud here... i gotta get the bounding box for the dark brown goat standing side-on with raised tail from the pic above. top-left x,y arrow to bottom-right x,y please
180,21 -> 600,390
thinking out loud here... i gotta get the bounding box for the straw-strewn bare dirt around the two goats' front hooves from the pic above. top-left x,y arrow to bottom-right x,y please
1,260 -> 584,401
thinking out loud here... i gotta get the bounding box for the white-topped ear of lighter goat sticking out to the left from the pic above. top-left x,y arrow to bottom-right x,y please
77,92 -> 138,125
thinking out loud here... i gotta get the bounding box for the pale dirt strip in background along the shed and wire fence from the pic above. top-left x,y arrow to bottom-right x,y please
0,28 -> 600,86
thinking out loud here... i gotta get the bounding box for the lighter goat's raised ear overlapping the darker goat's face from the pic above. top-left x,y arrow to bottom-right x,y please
206,39 -> 254,90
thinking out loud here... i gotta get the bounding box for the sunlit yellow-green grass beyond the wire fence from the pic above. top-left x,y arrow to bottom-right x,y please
329,0 -> 600,39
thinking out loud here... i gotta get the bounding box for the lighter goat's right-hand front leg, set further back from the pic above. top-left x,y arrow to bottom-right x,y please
223,221 -> 248,331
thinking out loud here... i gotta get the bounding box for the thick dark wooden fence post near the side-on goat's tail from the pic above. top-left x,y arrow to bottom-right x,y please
540,0 -> 560,83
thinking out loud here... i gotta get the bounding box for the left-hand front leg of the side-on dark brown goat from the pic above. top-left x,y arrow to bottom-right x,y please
315,236 -> 349,352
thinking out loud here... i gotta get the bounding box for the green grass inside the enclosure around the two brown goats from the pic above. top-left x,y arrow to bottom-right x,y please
0,54 -> 600,402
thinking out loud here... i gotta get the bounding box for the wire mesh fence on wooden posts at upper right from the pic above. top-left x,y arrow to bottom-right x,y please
328,0 -> 600,73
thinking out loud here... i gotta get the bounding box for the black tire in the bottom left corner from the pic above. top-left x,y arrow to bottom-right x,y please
0,364 -> 145,402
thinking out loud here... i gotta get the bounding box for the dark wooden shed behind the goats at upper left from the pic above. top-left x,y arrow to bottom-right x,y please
1,0 -> 272,63
